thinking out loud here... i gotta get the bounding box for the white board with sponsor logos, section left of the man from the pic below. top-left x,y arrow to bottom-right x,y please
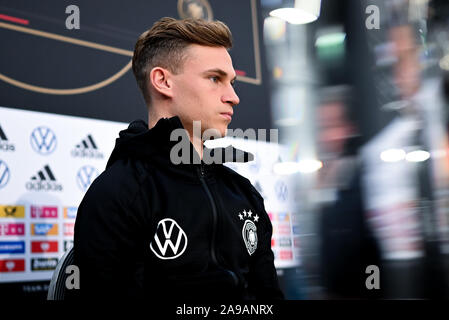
0,107 -> 127,283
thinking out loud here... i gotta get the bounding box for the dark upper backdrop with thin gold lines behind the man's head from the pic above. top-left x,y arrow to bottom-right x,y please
0,0 -> 271,129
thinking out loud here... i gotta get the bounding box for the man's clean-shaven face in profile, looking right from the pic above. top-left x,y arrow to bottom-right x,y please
172,45 -> 240,137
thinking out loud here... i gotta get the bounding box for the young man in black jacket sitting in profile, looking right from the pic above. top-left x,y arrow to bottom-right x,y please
74,18 -> 283,300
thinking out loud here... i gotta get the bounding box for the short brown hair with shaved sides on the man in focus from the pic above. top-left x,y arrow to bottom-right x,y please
132,17 -> 232,104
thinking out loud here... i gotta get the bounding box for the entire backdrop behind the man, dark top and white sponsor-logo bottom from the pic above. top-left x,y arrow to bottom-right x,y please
0,0 -> 300,294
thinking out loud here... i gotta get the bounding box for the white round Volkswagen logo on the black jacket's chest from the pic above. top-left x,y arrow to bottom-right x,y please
150,218 -> 187,260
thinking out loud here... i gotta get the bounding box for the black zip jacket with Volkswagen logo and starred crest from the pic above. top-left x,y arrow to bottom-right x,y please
72,117 -> 283,301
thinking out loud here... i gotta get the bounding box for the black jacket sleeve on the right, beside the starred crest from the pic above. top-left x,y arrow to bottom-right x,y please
248,188 -> 284,300
